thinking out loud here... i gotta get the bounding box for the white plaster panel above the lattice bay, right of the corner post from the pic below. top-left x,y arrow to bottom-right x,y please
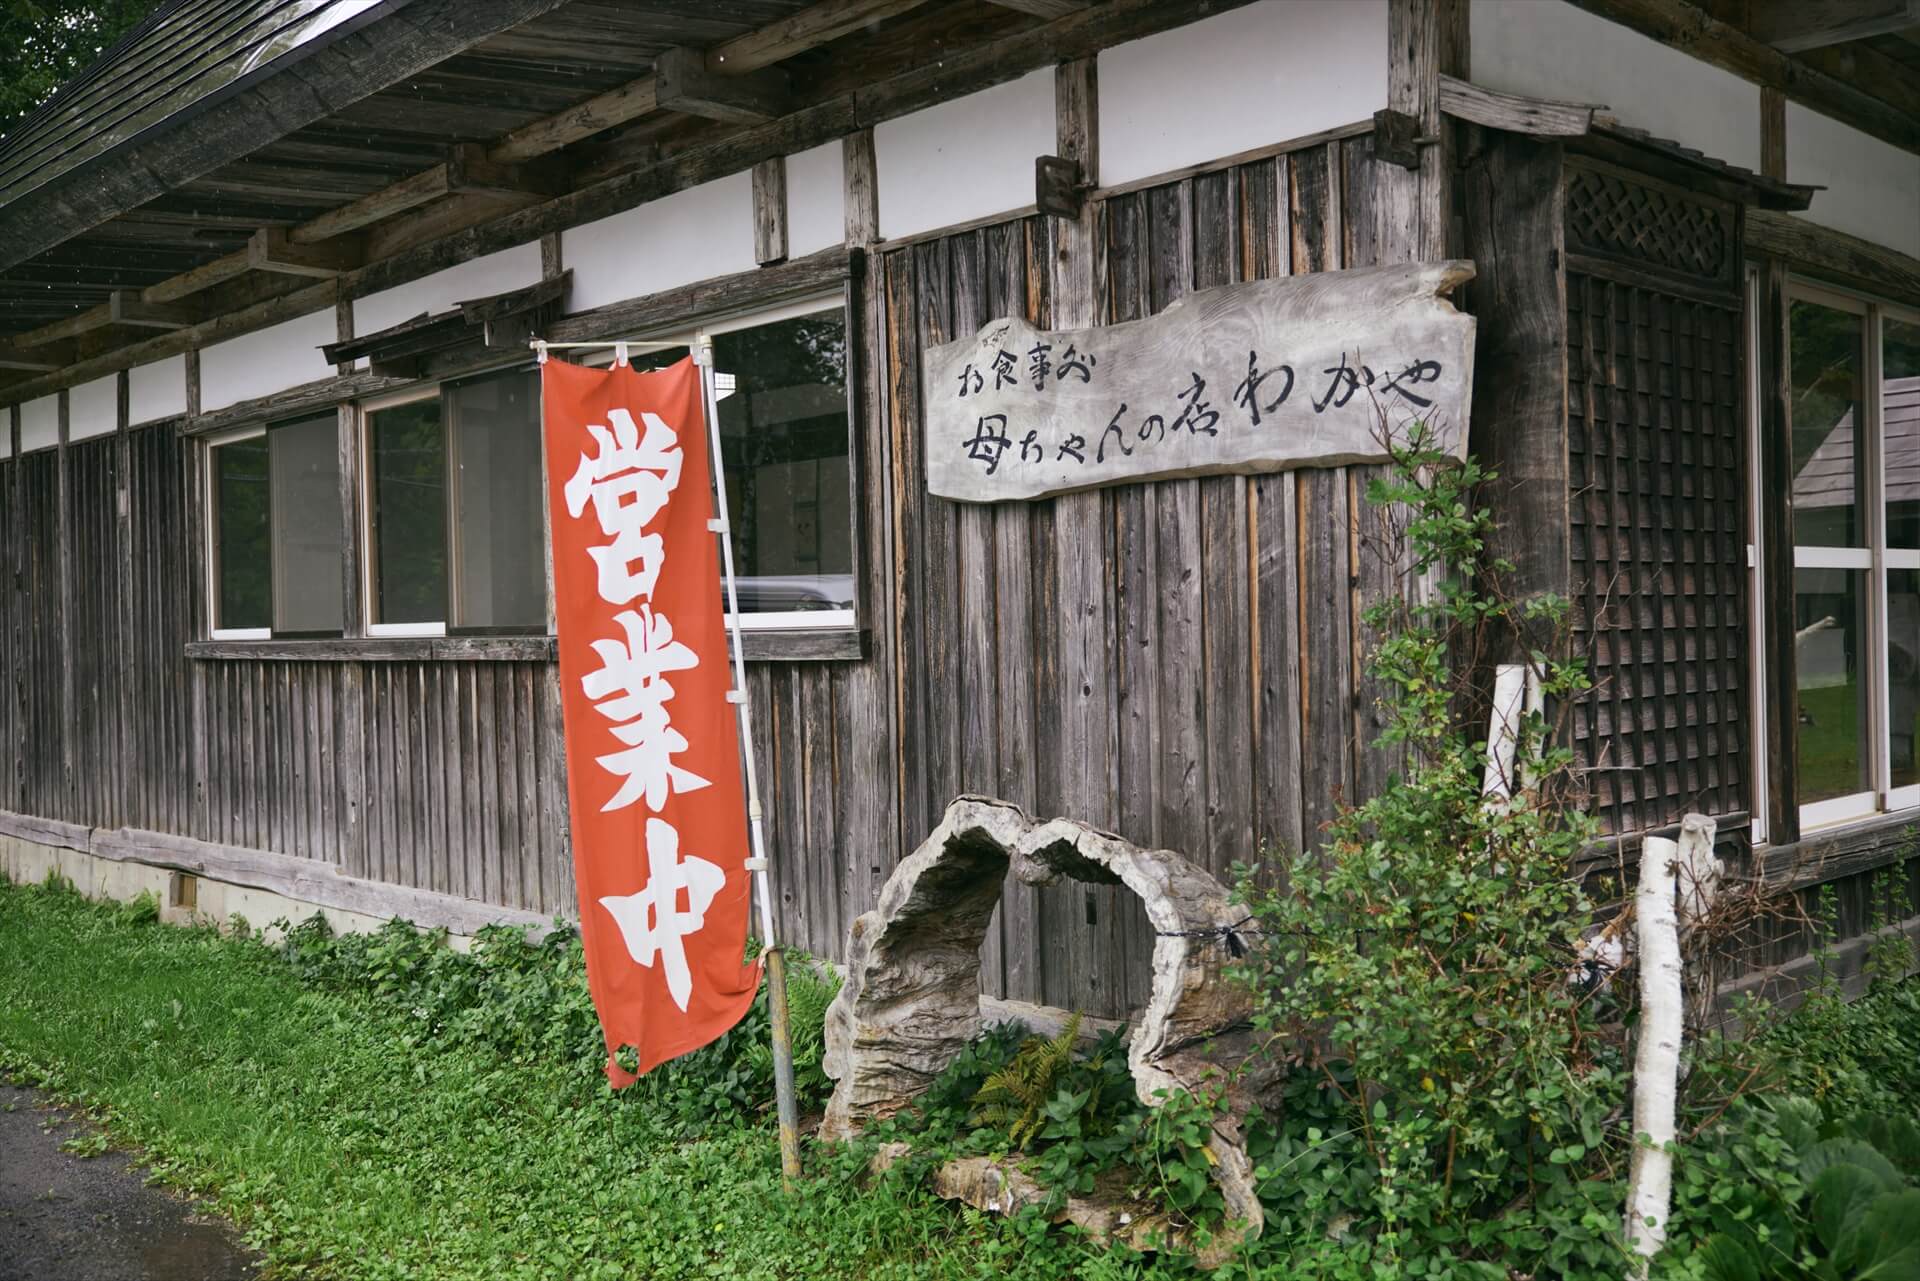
1466,0 -> 1758,169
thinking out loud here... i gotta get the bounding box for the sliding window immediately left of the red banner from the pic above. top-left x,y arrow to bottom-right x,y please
367,369 -> 547,636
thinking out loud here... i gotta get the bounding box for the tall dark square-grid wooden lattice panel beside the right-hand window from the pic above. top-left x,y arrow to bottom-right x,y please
1567,273 -> 1749,834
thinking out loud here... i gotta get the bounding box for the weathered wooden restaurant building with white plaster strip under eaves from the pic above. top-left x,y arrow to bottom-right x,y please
0,0 -> 1920,1014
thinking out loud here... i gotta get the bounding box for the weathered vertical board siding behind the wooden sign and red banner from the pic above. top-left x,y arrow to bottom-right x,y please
0,138 -> 1396,1014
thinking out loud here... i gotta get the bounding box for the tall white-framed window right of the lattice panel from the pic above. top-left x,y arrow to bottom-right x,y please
1788,286 -> 1920,828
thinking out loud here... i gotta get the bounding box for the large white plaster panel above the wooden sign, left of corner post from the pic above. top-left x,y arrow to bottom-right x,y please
1105,0 -> 1390,188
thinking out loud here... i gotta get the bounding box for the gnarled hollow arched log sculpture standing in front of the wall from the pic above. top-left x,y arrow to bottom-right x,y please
820,797 -> 1261,1266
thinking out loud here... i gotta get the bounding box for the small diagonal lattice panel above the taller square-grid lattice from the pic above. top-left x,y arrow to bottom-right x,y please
1567,165 -> 1736,284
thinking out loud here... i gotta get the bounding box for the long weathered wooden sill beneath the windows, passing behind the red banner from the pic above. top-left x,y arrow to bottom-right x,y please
186,628 -> 868,663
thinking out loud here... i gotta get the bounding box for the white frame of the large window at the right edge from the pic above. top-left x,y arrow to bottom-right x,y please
1749,277 -> 1920,841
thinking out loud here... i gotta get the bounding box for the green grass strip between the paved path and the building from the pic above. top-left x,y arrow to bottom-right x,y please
0,883 -> 1158,1281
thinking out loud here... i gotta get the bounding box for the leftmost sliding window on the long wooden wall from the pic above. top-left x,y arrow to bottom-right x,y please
207,411 -> 344,638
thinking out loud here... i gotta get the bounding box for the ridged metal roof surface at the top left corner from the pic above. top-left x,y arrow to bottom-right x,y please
0,0 -> 389,205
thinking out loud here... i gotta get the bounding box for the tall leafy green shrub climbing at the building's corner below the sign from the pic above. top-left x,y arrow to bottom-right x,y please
1236,426 -> 1624,1275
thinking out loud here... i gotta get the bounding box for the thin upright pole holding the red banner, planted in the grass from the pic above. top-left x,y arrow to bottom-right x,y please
693,332 -> 801,1185
